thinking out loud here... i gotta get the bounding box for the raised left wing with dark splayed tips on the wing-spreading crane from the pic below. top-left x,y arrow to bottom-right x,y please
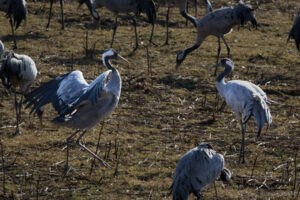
25,71 -> 88,115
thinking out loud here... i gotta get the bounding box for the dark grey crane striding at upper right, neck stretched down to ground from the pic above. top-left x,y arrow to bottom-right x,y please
176,3 -> 257,75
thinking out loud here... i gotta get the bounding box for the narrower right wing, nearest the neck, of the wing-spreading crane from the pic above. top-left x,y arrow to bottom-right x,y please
60,70 -> 111,115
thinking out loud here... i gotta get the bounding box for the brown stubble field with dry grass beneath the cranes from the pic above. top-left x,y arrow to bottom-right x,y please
0,0 -> 300,199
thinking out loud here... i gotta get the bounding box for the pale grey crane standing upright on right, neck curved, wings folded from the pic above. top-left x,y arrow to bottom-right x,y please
216,58 -> 272,163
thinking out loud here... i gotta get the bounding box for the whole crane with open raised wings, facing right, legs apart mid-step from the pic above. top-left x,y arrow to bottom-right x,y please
25,49 -> 128,172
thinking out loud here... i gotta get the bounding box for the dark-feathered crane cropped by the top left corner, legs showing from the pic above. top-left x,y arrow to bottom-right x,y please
0,0 -> 27,49
